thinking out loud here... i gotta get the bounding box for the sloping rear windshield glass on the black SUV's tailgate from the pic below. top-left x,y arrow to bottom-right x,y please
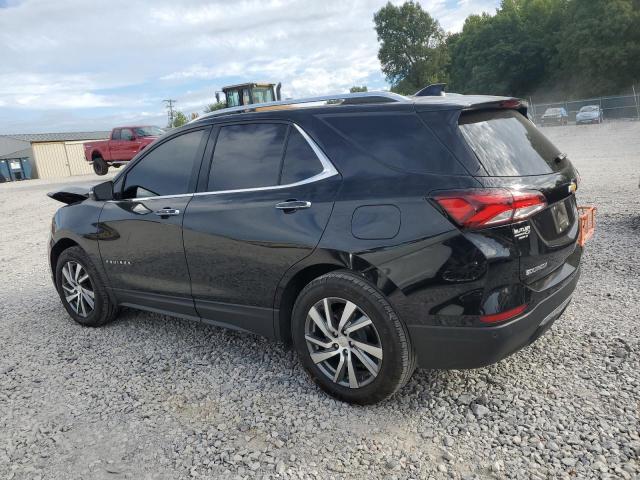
459,110 -> 563,177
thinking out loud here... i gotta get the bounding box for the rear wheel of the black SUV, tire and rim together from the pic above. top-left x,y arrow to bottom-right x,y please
291,271 -> 416,405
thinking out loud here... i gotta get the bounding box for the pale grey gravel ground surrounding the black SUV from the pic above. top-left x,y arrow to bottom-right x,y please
0,122 -> 640,479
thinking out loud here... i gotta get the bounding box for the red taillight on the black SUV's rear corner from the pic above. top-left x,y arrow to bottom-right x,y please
433,188 -> 547,228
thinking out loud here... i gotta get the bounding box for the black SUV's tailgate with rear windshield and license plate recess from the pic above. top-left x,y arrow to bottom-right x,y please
459,110 -> 578,283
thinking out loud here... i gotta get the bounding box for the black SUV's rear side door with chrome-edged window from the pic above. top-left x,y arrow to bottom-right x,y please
184,122 -> 340,336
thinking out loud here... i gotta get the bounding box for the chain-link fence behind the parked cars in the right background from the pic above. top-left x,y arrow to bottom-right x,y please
529,88 -> 640,123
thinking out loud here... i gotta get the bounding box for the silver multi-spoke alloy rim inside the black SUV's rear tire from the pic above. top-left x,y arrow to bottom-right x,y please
305,297 -> 383,388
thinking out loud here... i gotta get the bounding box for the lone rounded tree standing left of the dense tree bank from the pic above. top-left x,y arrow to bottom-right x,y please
373,1 -> 448,93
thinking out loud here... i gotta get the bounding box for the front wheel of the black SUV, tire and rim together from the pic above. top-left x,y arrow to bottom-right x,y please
56,247 -> 118,327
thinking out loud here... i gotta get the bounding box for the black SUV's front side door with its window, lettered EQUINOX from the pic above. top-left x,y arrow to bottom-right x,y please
98,128 -> 209,317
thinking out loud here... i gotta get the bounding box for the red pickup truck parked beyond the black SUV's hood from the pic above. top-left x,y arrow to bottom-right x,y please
84,125 -> 164,175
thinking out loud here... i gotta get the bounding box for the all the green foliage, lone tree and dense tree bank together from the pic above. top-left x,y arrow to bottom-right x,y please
374,0 -> 640,99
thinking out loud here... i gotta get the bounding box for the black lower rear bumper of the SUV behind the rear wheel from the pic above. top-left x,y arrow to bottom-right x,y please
408,269 -> 580,369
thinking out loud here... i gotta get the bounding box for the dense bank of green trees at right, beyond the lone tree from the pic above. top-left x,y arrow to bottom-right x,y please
447,0 -> 640,100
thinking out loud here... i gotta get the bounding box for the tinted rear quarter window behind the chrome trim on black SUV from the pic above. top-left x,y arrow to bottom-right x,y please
324,113 -> 465,174
